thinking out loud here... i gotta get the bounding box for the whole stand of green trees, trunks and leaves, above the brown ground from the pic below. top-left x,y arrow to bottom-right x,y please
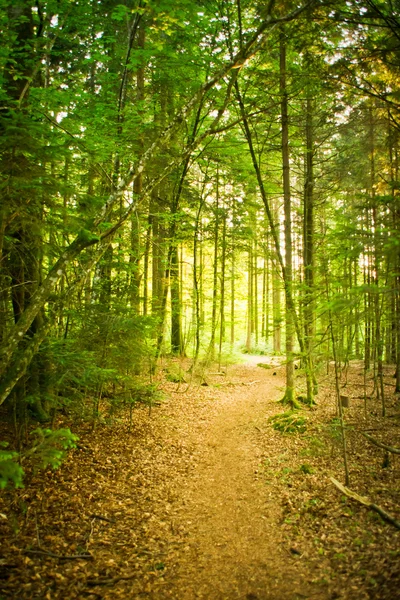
0,0 -> 400,452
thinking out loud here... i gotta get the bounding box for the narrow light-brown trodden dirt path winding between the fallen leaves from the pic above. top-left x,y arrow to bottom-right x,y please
156,361 -> 322,600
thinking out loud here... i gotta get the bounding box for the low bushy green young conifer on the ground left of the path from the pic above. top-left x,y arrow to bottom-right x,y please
38,305 -> 155,419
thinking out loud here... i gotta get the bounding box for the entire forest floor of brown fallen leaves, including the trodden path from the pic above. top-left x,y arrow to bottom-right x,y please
0,357 -> 400,600
